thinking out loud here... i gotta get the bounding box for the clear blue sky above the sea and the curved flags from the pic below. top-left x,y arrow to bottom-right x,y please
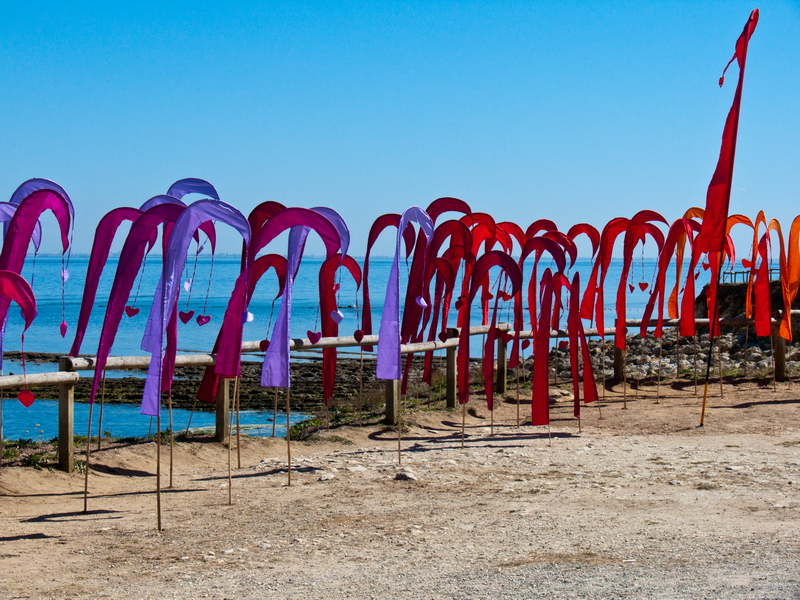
0,0 -> 800,255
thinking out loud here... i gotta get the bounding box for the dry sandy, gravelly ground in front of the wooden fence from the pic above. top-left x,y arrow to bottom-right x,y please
0,381 -> 800,599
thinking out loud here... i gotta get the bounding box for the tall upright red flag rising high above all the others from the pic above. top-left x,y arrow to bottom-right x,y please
696,9 -> 758,253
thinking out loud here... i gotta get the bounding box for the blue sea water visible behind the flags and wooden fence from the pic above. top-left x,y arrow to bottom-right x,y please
3,254 -> 704,439
